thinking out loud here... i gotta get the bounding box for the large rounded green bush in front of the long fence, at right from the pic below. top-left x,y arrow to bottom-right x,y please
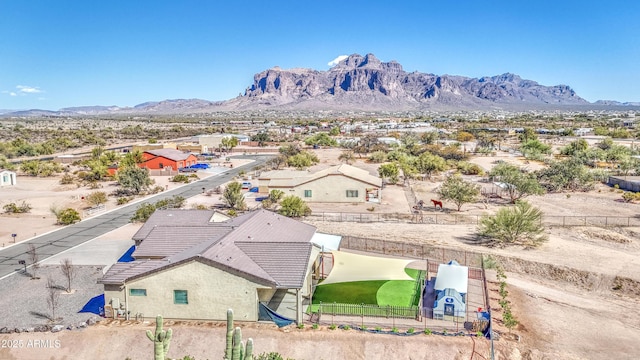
478,200 -> 547,248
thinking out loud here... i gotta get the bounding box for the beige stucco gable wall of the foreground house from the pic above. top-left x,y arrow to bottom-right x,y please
105,261 -> 268,321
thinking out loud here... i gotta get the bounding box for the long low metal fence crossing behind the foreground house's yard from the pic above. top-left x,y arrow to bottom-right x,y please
305,212 -> 640,227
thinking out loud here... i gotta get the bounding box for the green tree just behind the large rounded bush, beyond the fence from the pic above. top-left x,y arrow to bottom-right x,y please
489,163 -> 544,204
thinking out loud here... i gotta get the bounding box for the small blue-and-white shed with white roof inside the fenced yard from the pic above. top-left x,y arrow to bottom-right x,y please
433,260 -> 469,320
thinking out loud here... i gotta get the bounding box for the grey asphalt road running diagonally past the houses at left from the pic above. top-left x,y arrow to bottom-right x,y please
0,155 -> 271,279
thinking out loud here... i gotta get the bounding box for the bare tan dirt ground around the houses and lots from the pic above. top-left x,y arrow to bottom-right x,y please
0,149 -> 640,360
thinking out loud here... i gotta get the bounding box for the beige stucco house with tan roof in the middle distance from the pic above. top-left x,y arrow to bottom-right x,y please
258,164 -> 382,203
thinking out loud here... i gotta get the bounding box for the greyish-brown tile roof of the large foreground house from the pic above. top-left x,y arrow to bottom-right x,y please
100,210 -> 316,288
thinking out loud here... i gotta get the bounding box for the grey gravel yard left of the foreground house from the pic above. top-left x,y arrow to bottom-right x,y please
0,266 -> 103,331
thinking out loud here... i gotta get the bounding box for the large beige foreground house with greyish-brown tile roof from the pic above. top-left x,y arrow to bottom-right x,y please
99,209 -> 320,322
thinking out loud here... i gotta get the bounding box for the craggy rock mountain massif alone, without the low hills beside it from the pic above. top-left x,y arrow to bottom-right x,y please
229,54 -> 589,110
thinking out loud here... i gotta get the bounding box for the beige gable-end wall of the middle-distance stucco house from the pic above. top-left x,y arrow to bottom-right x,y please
278,175 -> 375,203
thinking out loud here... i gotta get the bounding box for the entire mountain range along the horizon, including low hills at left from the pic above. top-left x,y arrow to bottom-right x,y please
4,54 -> 640,116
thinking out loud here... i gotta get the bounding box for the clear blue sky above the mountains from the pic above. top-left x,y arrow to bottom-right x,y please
0,0 -> 640,110
